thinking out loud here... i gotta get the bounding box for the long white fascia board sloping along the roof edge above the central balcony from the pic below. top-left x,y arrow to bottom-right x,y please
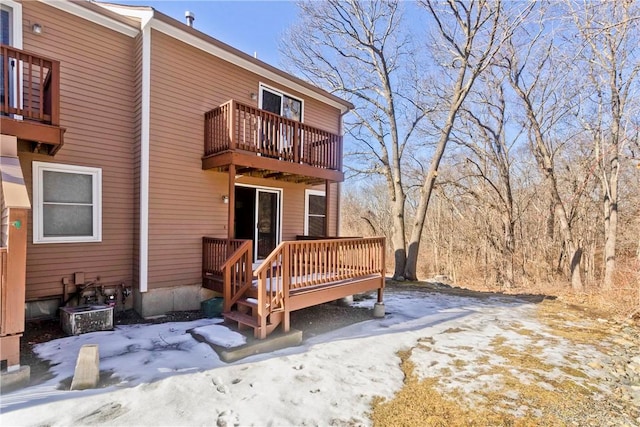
150,19 -> 348,113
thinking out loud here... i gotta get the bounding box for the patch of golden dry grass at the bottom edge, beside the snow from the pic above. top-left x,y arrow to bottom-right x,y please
372,348 -> 587,427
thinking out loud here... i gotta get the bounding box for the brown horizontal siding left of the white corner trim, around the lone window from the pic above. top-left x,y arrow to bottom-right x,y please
20,2 -> 137,299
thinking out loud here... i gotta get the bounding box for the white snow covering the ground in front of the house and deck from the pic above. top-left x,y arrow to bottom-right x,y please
0,291 -> 604,426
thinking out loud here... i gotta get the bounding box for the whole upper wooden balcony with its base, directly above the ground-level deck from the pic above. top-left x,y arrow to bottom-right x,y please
202,100 -> 344,184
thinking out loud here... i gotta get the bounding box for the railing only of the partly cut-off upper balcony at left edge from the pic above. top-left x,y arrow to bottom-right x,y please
0,44 -> 60,126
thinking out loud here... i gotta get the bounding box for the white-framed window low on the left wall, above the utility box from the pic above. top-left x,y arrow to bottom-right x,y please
33,162 -> 102,243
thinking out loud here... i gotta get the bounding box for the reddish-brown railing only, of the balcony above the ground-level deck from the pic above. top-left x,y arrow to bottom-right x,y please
204,100 -> 342,171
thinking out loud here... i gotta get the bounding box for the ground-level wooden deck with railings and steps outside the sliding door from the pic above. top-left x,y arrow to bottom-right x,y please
203,237 -> 385,339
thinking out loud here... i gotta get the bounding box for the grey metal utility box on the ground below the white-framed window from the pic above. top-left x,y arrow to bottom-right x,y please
60,305 -> 113,335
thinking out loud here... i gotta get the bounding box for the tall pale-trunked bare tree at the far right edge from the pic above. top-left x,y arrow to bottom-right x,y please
568,1 -> 640,289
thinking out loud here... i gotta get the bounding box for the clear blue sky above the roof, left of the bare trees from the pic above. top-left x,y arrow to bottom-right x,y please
109,0 -> 296,68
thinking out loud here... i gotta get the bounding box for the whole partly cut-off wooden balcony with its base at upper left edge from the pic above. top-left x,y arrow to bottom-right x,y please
0,45 -> 65,155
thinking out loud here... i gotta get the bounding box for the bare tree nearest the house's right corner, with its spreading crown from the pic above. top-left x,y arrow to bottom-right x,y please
282,0 -> 425,277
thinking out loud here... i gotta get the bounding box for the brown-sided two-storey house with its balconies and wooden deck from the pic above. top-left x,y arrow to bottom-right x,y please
0,0 -> 384,376
